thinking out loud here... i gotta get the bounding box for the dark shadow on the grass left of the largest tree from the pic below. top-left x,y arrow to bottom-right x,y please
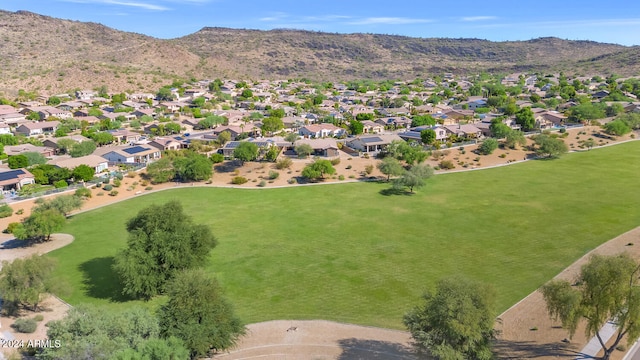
79,256 -> 133,302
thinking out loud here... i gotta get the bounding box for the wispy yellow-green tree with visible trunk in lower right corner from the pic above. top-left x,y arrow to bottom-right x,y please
541,254 -> 640,360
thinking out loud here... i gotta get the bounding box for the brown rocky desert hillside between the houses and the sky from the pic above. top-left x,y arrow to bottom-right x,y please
0,11 -> 640,94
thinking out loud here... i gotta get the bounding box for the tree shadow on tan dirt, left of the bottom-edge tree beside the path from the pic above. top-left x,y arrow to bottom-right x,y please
338,338 -> 430,360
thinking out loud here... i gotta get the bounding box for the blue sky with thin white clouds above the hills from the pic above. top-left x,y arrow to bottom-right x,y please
0,0 -> 640,46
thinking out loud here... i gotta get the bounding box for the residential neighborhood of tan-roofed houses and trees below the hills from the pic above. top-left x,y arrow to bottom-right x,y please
0,73 -> 640,198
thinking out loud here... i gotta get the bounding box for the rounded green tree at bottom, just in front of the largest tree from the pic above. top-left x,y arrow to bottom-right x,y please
159,269 -> 245,358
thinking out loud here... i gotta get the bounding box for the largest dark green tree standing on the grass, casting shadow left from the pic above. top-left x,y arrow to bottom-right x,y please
113,201 -> 217,299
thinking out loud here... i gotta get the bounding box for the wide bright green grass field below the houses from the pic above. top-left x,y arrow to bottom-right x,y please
50,142 -> 640,328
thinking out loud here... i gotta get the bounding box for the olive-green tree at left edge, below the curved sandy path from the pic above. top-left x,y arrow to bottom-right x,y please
0,255 -> 55,313
